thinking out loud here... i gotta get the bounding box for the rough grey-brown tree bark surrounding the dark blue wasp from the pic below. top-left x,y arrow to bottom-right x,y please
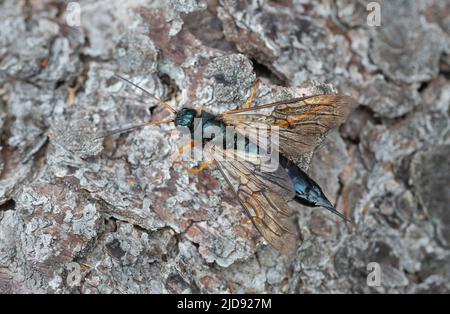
0,0 -> 450,293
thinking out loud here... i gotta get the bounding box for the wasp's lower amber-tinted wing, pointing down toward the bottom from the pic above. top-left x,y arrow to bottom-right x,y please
207,148 -> 298,255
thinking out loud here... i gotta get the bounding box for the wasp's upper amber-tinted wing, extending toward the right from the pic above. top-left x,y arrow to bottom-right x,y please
220,94 -> 357,159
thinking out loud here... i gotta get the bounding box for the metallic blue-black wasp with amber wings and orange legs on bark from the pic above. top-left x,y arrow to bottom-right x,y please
101,75 -> 357,255
